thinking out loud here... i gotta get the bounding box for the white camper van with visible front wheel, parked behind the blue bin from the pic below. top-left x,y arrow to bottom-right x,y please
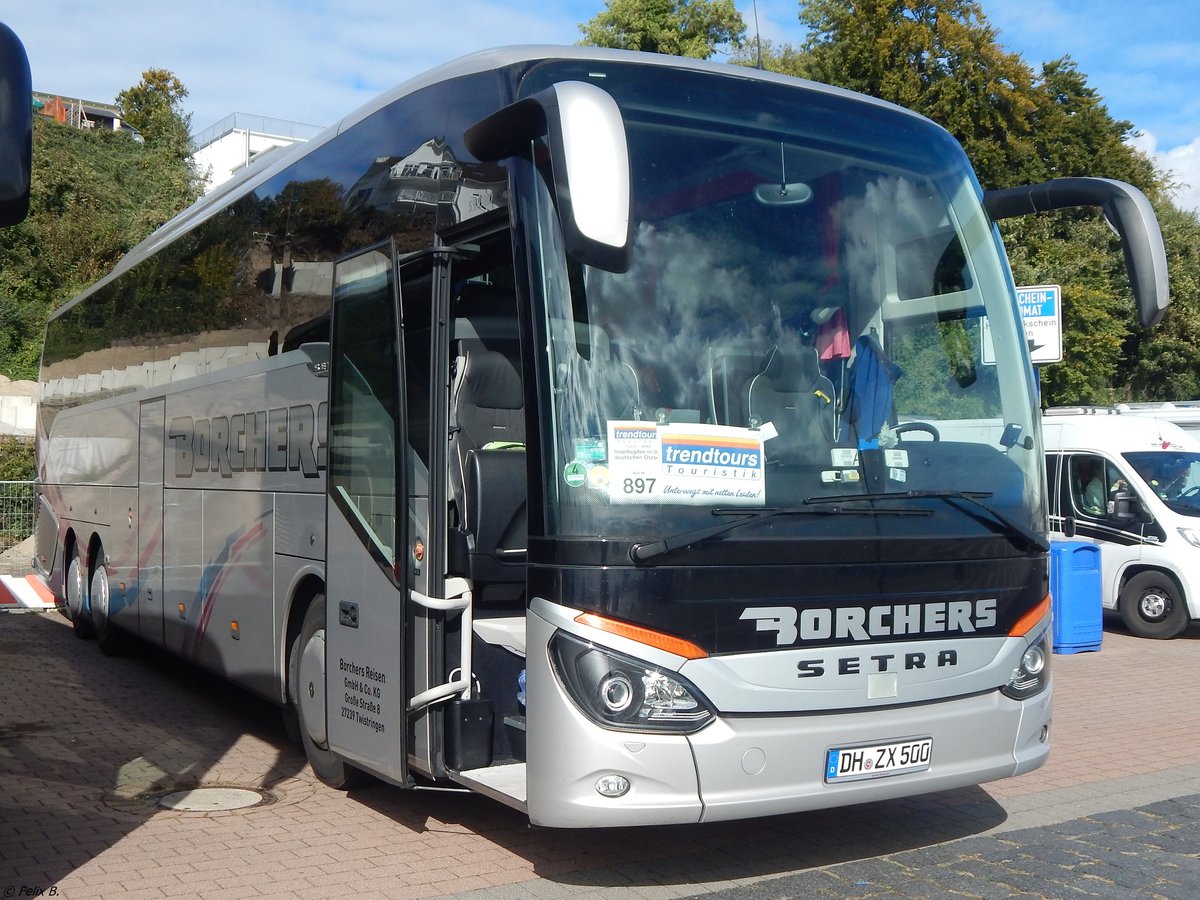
1042,407 -> 1200,638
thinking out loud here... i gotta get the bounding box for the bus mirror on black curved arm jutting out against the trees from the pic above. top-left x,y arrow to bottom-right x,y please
983,178 -> 1170,328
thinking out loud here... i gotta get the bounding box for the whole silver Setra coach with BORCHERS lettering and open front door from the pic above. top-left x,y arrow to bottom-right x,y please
35,48 -> 1168,827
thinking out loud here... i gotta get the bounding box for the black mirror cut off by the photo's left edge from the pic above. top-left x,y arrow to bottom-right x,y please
0,23 -> 34,226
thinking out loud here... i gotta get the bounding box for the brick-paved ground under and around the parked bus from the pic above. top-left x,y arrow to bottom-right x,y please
0,612 -> 1200,900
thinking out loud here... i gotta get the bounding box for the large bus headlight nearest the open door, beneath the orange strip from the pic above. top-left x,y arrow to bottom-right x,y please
550,631 -> 714,734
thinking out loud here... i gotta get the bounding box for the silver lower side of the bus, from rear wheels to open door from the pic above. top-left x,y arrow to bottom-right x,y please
37,352 -> 325,702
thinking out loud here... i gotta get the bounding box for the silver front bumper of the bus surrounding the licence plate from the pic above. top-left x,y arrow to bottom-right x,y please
528,599 -> 1052,828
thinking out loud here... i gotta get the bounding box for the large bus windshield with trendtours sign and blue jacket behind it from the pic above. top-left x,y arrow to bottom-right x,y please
522,62 -> 1043,547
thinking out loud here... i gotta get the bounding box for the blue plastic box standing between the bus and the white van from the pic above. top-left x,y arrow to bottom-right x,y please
1050,541 -> 1104,653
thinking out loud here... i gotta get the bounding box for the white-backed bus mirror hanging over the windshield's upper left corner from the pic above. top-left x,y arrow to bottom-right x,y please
464,82 -> 631,272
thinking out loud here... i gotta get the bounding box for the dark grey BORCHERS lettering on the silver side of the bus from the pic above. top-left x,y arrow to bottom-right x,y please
167,403 -> 329,478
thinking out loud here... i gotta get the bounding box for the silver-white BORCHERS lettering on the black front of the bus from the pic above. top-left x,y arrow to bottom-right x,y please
739,598 -> 996,647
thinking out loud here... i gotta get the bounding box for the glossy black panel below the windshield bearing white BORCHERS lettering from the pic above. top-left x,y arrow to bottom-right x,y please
529,540 -> 1048,654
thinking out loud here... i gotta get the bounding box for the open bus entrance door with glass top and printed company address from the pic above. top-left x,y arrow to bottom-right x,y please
321,242 -> 408,785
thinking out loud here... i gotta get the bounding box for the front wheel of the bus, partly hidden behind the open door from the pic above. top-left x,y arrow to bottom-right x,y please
288,594 -> 370,791
